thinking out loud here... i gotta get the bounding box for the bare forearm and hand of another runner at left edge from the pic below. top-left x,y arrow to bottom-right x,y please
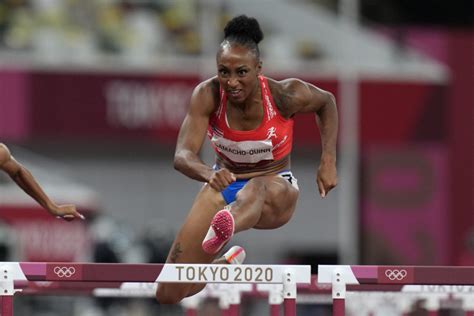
0,143 -> 84,220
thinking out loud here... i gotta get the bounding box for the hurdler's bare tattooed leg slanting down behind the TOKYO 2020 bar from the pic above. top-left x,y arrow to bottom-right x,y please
167,185 -> 225,263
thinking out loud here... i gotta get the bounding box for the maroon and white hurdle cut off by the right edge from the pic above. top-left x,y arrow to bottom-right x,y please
318,265 -> 474,316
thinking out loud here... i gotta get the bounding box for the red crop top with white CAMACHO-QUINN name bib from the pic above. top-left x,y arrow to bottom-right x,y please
207,76 -> 293,165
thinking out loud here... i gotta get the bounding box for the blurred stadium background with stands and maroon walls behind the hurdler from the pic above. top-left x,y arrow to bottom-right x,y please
0,0 -> 474,316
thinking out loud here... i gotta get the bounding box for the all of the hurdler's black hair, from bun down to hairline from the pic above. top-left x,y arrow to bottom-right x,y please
224,15 -> 263,59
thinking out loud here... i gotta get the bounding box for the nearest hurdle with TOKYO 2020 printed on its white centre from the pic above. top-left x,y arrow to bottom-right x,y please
0,262 -> 311,316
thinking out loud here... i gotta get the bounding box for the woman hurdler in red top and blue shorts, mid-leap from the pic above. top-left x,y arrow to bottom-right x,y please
156,15 -> 338,304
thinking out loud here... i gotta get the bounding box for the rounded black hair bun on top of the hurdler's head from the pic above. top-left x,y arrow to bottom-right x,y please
224,15 -> 263,44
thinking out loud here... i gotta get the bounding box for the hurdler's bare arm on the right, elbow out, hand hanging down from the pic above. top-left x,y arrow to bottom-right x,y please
289,80 -> 339,198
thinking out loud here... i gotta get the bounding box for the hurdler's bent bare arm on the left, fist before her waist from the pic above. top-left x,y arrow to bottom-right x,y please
174,80 -> 235,191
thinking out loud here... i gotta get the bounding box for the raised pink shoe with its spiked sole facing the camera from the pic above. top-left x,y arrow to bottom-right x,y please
202,209 -> 234,254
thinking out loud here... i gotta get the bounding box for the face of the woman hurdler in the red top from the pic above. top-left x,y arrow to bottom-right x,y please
216,43 -> 262,103
